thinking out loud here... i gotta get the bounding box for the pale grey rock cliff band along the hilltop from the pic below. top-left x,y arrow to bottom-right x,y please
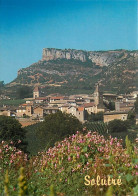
42,48 -> 130,66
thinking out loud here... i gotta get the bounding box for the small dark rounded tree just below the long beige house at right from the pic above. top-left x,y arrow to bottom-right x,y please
108,119 -> 127,133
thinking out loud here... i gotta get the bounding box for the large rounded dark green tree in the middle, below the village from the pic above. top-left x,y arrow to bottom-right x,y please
37,111 -> 82,148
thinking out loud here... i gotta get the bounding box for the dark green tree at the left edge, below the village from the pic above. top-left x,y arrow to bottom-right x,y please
0,116 -> 27,151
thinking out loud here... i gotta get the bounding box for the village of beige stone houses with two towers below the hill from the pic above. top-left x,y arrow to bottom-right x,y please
0,84 -> 138,127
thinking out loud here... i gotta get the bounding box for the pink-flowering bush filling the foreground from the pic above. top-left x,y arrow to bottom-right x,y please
0,132 -> 138,195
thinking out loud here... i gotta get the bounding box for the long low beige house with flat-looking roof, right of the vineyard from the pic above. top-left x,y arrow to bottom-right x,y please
104,111 -> 128,123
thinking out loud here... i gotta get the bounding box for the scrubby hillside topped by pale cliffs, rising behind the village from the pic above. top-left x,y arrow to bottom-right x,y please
8,48 -> 138,94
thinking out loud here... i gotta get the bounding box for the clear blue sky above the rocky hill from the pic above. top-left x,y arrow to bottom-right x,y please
0,0 -> 138,83
